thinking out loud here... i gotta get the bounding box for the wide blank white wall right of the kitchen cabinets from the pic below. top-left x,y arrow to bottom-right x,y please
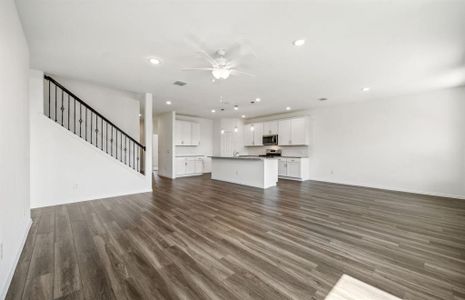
310,88 -> 465,197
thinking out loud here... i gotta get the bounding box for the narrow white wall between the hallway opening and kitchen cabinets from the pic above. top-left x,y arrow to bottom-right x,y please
157,112 -> 176,178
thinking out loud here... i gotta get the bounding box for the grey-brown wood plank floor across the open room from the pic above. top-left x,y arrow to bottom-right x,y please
7,176 -> 465,299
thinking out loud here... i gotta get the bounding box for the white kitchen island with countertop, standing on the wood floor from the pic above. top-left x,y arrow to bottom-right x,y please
211,156 -> 278,189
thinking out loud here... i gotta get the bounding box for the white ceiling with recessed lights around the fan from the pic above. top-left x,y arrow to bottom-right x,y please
17,0 -> 465,117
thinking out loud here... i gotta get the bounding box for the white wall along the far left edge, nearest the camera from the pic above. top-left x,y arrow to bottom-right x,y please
0,0 -> 31,299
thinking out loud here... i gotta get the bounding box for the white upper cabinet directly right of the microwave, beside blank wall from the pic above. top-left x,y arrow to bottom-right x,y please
278,117 -> 309,146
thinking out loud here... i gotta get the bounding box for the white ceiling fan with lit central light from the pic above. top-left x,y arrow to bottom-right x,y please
183,44 -> 255,80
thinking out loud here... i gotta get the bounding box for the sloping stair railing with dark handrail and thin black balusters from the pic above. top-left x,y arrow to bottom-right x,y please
44,75 -> 145,174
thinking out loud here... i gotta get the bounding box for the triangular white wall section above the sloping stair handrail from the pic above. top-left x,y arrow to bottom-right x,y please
51,75 -> 141,141
